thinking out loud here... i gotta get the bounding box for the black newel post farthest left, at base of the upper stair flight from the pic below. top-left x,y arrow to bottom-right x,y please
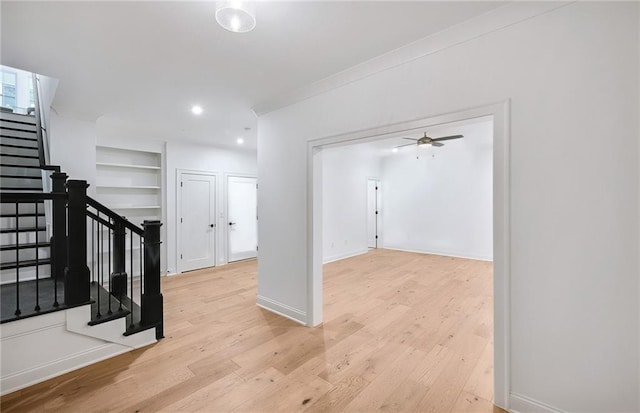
51,172 -> 67,280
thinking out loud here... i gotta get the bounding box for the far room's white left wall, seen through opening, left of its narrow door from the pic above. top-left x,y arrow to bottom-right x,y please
322,145 -> 380,262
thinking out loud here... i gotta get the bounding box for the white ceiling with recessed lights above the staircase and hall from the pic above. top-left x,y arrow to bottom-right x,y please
0,1 -> 504,148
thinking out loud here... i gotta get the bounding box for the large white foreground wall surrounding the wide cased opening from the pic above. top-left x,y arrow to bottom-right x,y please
258,3 -> 640,412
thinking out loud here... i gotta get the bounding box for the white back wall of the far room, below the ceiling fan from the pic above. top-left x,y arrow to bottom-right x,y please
382,121 -> 493,260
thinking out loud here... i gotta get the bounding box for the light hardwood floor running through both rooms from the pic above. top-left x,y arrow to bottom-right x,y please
0,249 -> 498,412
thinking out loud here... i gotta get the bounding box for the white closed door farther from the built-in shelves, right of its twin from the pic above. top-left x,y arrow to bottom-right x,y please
227,176 -> 258,262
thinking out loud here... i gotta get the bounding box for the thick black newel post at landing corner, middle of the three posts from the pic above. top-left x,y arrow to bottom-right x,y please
64,180 -> 91,306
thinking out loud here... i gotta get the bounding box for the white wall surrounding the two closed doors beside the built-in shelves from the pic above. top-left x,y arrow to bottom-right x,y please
166,141 -> 262,274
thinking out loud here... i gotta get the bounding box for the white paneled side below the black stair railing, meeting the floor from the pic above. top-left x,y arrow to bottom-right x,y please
0,305 -> 156,395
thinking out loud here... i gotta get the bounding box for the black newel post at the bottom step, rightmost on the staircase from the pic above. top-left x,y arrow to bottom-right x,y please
140,220 -> 164,339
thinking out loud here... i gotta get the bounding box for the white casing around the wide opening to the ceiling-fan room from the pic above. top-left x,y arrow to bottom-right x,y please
306,99 -> 511,408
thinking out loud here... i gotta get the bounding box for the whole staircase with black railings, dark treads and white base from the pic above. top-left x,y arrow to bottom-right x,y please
0,75 -> 163,395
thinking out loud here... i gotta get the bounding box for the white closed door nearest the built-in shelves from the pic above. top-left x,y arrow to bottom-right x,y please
178,172 -> 216,271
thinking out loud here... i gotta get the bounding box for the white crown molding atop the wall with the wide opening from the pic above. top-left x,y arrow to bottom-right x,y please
252,2 -> 572,116
